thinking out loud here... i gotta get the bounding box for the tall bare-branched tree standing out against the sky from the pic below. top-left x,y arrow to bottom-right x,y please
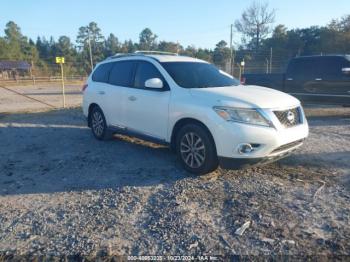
235,2 -> 275,50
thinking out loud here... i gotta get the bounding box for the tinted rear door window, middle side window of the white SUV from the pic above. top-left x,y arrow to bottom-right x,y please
109,61 -> 135,87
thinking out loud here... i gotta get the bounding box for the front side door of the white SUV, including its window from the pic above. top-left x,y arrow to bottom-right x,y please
123,61 -> 170,140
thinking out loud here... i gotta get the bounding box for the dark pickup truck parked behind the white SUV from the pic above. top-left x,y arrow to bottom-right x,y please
243,55 -> 350,106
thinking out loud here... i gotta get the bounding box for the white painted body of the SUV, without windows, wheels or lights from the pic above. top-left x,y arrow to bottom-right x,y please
83,55 -> 308,168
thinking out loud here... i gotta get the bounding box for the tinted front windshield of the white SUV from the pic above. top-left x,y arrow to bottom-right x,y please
161,62 -> 239,88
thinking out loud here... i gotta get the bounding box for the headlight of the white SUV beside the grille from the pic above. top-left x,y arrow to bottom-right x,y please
214,106 -> 273,127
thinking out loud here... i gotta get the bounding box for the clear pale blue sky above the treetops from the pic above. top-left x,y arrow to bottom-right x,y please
0,0 -> 350,48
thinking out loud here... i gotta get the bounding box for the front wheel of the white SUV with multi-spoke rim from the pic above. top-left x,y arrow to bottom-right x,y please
176,124 -> 218,175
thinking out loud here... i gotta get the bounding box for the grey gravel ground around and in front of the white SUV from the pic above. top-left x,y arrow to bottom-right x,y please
0,107 -> 350,259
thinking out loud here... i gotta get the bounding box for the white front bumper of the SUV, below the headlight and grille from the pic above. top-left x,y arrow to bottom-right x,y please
211,106 -> 309,162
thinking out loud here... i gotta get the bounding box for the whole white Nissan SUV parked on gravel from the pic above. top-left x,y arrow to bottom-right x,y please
83,52 -> 308,174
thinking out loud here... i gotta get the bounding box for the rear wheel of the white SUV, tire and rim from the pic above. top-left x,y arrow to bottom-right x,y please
89,106 -> 112,140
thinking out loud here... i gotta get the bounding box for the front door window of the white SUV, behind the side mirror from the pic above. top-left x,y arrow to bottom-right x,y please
134,62 -> 165,88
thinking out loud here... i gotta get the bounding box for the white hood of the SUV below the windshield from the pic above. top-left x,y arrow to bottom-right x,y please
190,85 -> 300,109
